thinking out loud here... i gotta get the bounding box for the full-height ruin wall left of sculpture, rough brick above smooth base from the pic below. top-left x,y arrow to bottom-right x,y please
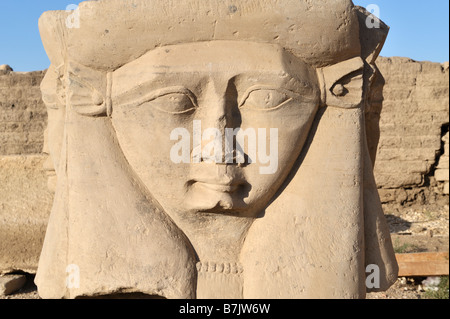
0,70 -> 53,274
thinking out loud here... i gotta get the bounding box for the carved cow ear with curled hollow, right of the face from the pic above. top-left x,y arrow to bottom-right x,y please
317,57 -> 364,109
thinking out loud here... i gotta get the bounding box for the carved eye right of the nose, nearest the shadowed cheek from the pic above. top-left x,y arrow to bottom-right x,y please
240,87 -> 294,111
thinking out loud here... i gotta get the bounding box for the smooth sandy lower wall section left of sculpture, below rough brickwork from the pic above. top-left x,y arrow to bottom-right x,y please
0,155 -> 53,274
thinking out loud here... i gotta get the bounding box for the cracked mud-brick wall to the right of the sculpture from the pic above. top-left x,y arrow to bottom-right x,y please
375,58 -> 449,202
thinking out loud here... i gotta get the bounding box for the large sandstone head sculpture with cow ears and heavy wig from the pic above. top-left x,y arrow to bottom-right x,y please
36,0 -> 397,298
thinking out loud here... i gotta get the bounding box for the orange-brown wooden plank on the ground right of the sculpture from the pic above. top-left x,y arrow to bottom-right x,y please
396,253 -> 449,277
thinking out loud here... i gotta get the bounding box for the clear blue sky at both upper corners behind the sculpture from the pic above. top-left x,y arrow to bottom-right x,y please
0,0 -> 449,71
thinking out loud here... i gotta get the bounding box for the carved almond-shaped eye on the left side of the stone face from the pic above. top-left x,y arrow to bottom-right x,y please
142,88 -> 196,114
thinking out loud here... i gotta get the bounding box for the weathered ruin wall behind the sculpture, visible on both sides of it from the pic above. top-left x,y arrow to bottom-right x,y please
0,58 -> 449,274
